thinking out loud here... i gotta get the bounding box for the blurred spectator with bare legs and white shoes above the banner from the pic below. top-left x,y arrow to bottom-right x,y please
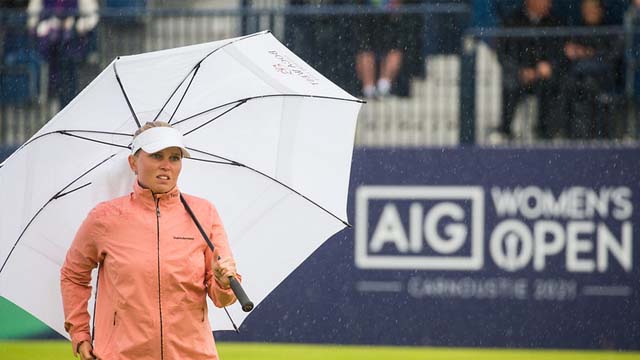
354,0 -> 404,98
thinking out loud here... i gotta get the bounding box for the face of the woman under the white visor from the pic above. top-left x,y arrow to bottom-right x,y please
129,147 -> 182,194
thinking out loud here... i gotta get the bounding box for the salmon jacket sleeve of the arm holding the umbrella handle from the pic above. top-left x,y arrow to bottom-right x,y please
205,206 -> 242,307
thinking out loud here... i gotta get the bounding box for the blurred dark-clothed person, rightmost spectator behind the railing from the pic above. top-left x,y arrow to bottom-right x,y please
559,0 -> 624,138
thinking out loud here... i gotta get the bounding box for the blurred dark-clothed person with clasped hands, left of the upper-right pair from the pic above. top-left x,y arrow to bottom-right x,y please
497,0 -> 563,139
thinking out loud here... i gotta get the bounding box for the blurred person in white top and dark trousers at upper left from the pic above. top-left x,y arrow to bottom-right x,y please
27,0 -> 98,107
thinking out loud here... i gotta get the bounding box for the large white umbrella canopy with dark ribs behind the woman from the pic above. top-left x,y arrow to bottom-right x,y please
0,32 -> 362,336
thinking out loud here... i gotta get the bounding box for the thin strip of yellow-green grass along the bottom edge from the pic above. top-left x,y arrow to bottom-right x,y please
0,341 -> 640,360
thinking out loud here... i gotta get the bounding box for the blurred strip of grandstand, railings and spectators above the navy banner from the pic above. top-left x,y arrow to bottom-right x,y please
0,0 -> 640,147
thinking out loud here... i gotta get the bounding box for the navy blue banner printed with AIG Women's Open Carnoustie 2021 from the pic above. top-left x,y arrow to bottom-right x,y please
216,148 -> 640,350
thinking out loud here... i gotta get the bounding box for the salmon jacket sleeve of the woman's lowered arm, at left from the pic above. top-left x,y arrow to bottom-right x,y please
60,209 -> 102,355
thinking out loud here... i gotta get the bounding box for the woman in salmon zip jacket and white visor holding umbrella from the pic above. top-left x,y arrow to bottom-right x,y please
61,121 -> 237,360
